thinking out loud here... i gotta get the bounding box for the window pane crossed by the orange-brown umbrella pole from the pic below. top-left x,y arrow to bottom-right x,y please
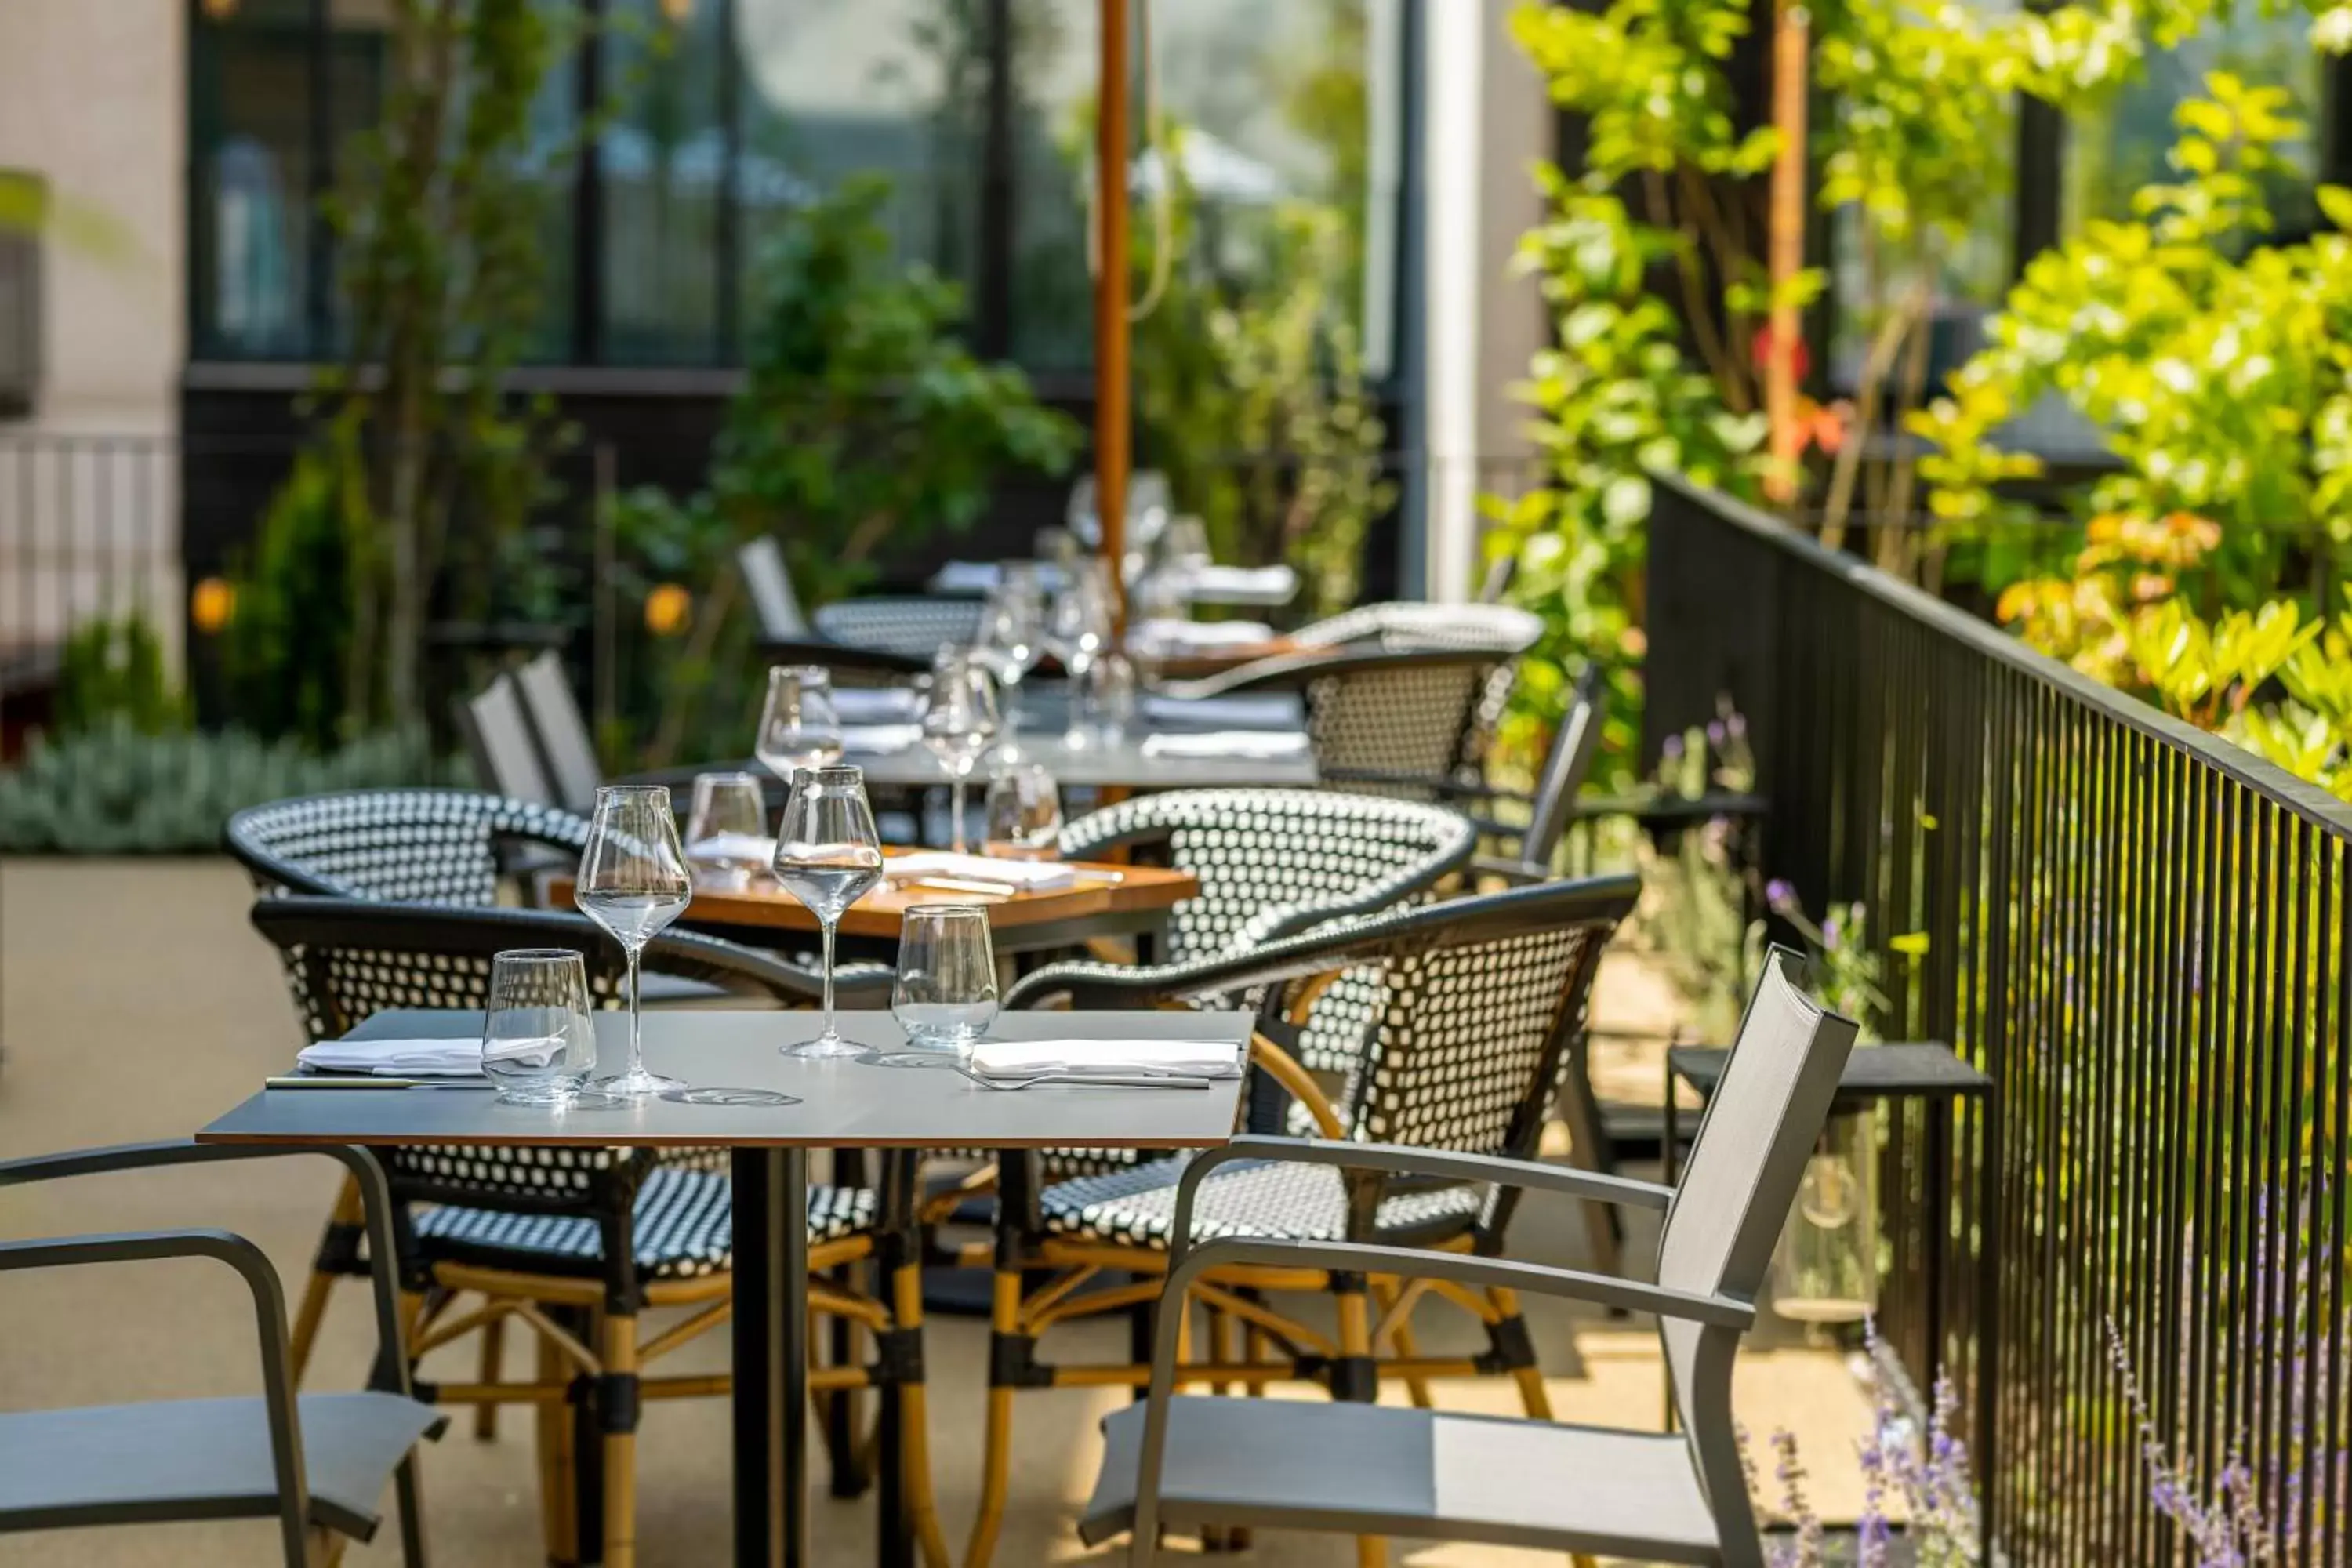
1011,0 -> 1402,374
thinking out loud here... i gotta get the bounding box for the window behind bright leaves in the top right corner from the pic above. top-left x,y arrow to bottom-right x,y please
2065,5 -> 2321,238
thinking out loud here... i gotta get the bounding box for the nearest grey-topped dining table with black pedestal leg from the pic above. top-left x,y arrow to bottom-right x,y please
195,1011 -> 1249,1568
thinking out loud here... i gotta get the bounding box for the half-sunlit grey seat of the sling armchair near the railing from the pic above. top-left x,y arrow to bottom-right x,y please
1080,1396 -> 1722,1563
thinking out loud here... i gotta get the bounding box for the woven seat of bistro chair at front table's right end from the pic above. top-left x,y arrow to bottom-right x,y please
1042,1159 -> 1486,1250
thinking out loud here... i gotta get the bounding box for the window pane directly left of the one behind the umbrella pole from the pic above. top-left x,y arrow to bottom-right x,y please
736,0 -> 988,320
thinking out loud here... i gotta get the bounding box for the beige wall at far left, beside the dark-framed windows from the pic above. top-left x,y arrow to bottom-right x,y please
0,0 -> 188,649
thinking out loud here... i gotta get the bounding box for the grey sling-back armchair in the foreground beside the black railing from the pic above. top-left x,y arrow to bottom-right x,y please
1080,949 -> 1853,1568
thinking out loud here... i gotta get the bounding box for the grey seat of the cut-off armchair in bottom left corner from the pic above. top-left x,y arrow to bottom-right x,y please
0,1394 -> 447,1540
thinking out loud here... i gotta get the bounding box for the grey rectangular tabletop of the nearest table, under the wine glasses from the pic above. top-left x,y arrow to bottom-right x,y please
195,1011 -> 1249,1149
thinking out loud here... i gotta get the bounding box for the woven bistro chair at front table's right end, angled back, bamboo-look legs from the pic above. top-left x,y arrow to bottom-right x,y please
967,877 -> 1637,1568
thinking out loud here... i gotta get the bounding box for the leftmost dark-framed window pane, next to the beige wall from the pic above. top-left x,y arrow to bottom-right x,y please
188,0 -> 310,360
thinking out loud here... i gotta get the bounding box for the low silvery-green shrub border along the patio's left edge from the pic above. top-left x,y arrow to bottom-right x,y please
0,715 -> 456,855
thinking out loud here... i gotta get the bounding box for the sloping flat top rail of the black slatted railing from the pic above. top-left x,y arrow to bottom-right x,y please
1651,473 -> 2352,841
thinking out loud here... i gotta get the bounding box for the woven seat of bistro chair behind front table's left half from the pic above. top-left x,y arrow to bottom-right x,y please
416,1166 -> 880,1279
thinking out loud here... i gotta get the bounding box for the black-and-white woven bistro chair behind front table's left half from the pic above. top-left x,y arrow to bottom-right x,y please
252,895 -> 946,1568
